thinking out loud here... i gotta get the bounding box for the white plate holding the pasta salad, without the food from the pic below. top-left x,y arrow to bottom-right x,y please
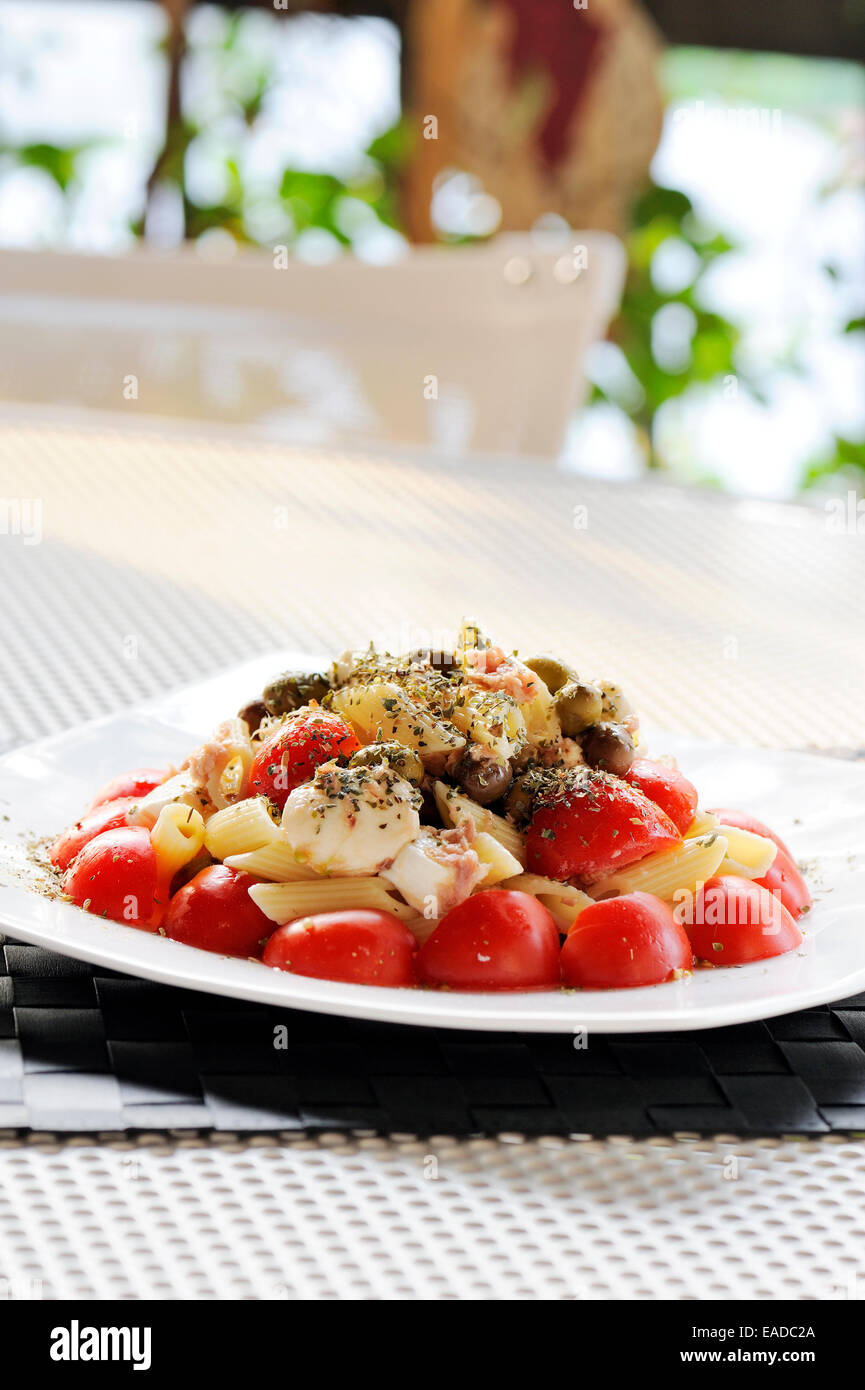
0,652 -> 865,1033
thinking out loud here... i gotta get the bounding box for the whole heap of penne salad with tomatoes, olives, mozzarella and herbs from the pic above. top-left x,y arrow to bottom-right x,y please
50,623 -> 811,991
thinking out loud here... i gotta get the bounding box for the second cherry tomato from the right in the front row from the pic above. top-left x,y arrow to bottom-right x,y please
562,892 -> 694,990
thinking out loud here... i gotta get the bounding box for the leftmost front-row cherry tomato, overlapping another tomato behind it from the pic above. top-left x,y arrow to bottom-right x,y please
63,826 -> 164,931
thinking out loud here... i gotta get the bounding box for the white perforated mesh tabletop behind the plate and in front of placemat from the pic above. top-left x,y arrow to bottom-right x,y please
0,421 -> 865,1300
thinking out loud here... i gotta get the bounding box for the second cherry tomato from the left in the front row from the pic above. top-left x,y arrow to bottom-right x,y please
163,865 -> 273,958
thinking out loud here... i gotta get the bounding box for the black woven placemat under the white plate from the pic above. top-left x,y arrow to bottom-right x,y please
0,940 -> 865,1137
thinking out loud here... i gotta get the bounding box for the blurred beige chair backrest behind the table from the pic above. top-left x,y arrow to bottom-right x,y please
0,232 -> 624,455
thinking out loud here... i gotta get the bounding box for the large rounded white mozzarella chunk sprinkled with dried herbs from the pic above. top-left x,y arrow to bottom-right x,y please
282,763 -> 421,876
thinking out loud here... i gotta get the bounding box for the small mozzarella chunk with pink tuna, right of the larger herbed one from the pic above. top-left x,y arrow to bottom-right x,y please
381,827 -> 488,917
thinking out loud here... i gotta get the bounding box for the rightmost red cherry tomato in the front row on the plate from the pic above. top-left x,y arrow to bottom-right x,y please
676,874 -> 802,965
